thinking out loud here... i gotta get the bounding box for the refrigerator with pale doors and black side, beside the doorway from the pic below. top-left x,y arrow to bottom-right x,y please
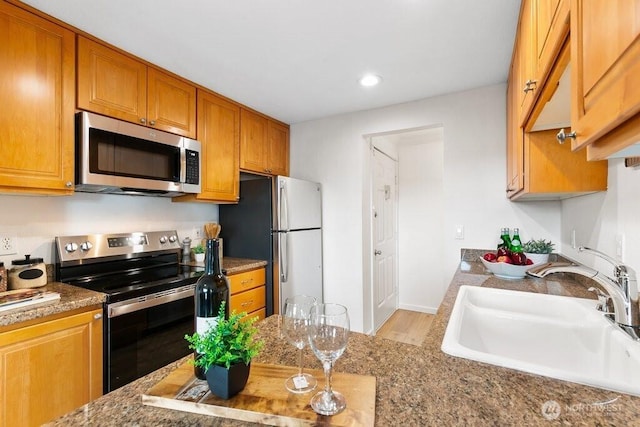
219,174 -> 323,315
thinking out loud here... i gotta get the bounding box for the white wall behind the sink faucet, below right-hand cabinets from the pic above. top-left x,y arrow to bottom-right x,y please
561,159 -> 640,276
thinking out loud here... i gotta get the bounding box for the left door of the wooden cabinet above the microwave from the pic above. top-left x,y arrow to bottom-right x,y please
78,36 -> 147,124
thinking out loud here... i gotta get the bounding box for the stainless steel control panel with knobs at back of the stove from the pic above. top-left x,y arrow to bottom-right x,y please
55,230 -> 180,263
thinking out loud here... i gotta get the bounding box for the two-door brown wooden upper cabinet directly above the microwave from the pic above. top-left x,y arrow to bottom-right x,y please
78,36 -> 196,139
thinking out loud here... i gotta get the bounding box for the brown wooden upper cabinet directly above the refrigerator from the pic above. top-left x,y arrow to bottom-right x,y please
240,108 -> 289,176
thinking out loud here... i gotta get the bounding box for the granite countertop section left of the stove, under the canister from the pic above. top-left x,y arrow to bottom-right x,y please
0,282 -> 106,327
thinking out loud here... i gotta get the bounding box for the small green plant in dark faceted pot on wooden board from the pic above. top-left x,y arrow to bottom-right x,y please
185,302 -> 264,399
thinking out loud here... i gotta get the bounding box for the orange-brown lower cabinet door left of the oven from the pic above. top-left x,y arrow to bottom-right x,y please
0,309 -> 102,426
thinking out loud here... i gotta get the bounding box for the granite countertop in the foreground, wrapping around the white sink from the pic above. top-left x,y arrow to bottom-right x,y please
45,253 -> 640,426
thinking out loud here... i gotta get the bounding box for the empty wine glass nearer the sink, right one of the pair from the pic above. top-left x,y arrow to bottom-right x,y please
309,303 -> 349,415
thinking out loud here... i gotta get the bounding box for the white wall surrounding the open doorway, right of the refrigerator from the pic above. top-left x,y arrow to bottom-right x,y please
291,84 -> 561,331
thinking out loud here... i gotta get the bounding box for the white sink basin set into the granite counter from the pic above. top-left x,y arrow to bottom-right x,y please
442,286 -> 640,396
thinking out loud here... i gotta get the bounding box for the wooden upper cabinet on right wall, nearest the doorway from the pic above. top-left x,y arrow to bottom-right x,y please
507,0 -> 607,201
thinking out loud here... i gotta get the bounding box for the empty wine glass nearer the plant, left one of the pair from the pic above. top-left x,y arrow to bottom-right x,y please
282,295 -> 318,393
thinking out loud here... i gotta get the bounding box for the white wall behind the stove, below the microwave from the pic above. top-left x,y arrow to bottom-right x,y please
0,193 -> 218,267
